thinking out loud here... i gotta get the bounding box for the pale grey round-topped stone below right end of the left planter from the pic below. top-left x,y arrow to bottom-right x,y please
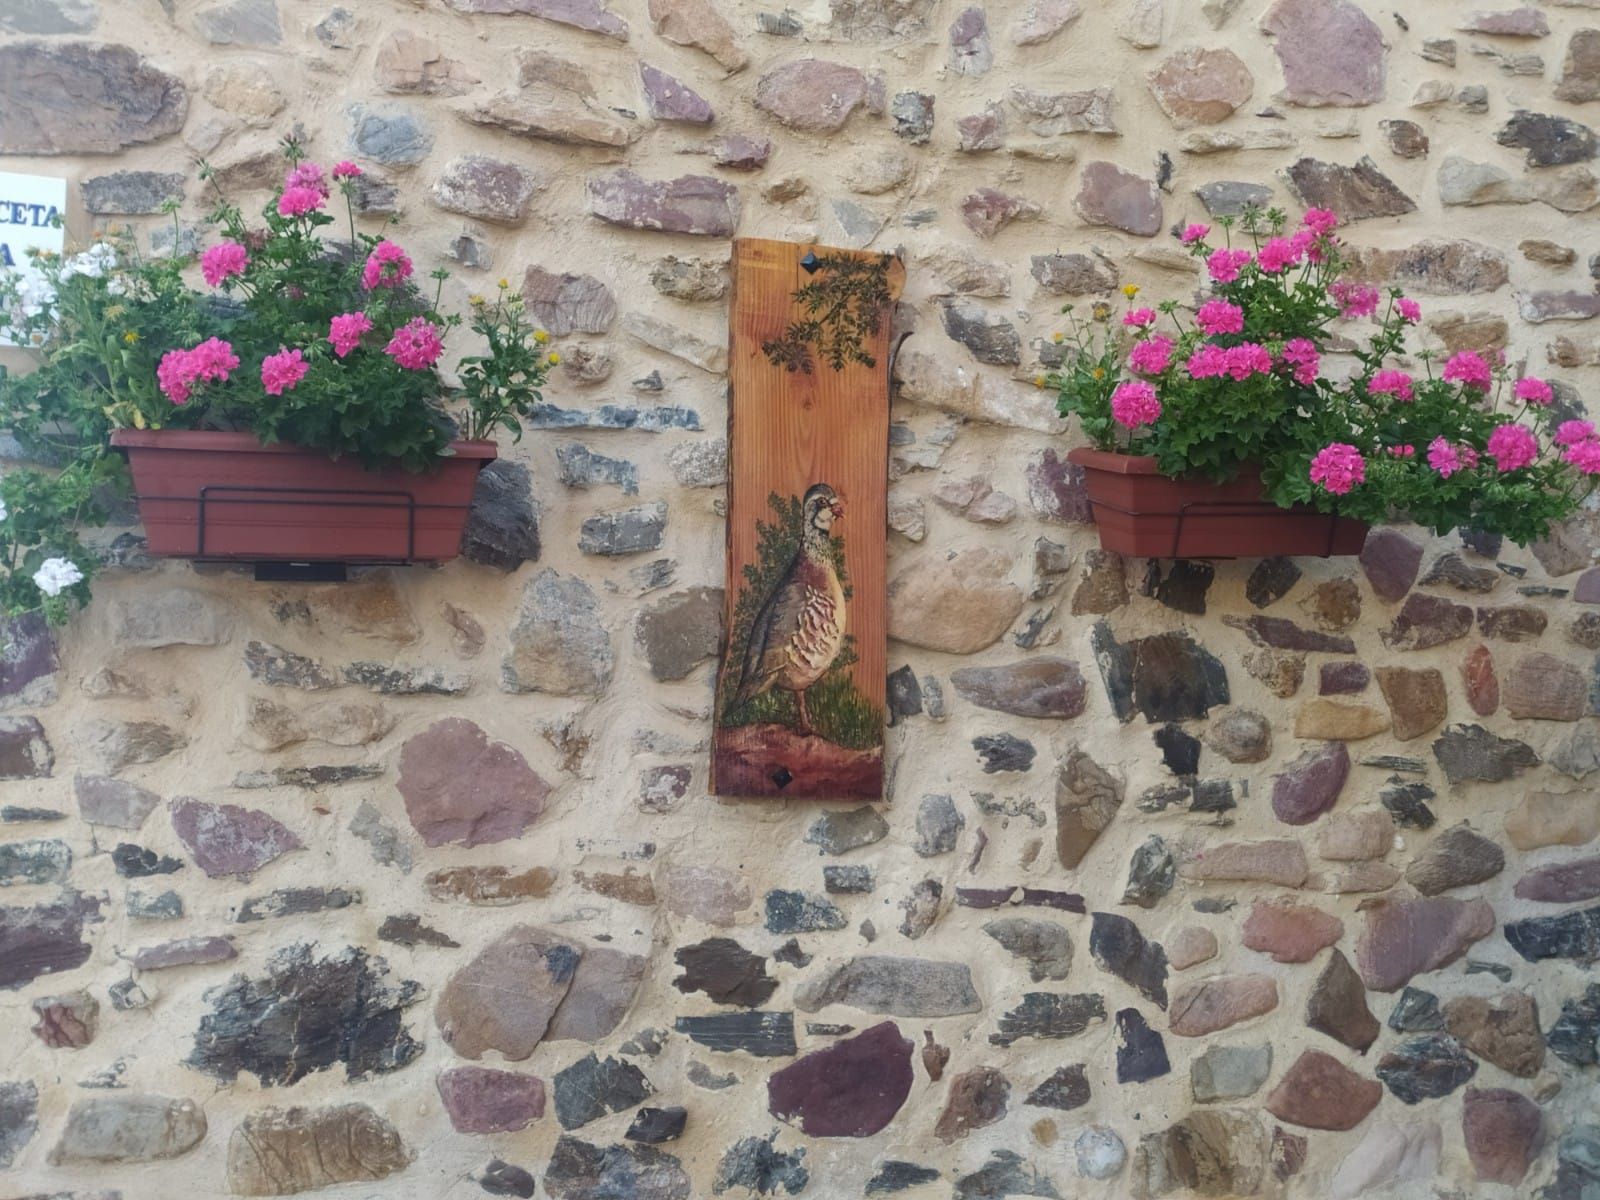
501,570 -> 614,696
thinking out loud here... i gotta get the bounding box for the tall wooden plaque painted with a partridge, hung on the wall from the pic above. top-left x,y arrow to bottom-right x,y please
710,238 -> 906,800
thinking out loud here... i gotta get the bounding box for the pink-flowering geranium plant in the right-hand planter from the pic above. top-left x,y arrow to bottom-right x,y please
1038,208 -> 1600,542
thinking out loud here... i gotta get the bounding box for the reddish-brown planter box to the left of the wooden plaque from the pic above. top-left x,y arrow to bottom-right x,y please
110,429 -> 496,563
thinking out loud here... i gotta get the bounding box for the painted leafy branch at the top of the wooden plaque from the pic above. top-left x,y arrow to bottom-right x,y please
762,254 -> 891,374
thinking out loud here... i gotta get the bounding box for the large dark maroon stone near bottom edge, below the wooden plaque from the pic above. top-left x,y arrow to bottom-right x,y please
766,1021 -> 912,1138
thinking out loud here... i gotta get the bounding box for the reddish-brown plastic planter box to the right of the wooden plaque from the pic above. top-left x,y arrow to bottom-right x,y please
1067,450 -> 1366,558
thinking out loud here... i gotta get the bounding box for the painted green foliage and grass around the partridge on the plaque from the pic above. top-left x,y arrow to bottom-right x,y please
717,491 -> 883,750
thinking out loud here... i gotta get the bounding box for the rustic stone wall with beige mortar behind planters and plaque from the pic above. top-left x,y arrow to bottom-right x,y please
0,0 -> 1600,1200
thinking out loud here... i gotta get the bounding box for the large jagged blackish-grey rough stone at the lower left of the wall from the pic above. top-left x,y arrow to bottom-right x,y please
184,944 -> 422,1088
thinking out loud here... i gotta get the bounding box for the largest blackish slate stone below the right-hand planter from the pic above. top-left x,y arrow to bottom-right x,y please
1091,621 -> 1229,725
